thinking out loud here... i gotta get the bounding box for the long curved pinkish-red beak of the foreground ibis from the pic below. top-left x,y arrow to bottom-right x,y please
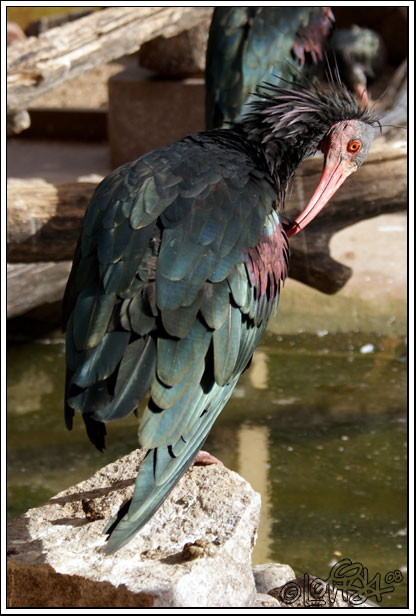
286,152 -> 357,237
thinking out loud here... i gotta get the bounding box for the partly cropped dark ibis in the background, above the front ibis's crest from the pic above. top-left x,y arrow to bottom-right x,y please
205,6 -> 334,129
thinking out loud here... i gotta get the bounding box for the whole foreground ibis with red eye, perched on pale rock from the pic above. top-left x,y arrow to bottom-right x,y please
64,77 -> 377,553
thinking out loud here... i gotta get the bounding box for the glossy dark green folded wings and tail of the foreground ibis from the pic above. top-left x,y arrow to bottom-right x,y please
65,138 -> 283,551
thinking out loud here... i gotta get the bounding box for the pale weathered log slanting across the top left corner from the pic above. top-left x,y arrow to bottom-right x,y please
7,6 -> 213,115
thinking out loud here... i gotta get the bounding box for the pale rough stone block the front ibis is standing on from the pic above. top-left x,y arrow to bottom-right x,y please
7,450 -> 374,608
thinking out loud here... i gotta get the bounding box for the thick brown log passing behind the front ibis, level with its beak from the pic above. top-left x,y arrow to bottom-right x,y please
7,138 -> 407,293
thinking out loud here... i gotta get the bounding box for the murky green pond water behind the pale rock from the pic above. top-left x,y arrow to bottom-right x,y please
7,331 -> 407,607
